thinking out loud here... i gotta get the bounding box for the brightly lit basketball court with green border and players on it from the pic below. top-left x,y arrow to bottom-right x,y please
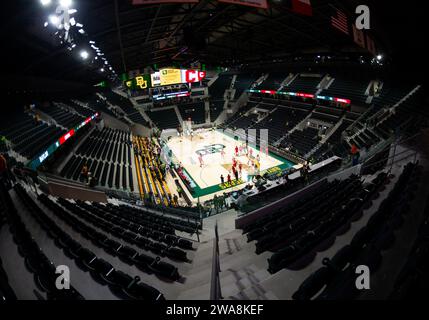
167,130 -> 294,196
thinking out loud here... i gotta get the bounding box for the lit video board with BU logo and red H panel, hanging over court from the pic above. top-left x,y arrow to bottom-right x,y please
125,68 -> 206,90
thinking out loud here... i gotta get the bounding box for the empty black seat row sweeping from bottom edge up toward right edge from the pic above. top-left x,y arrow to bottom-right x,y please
293,164 -> 420,300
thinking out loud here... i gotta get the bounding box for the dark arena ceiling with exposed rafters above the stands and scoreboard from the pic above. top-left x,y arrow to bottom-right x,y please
1,0 -> 422,81
